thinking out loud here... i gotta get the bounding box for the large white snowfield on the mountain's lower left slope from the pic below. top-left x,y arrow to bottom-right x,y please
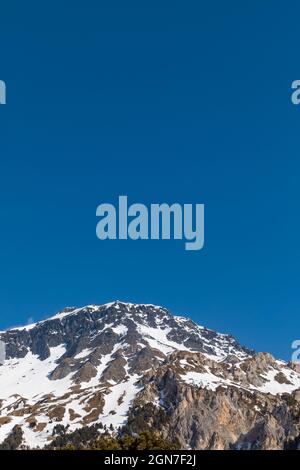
0,342 -> 145,447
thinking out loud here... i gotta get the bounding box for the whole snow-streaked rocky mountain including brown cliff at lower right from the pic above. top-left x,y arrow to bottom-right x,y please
0,301 -> 300,449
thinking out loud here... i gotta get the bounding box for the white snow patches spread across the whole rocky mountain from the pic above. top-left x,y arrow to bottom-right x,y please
0,301 -> 300,447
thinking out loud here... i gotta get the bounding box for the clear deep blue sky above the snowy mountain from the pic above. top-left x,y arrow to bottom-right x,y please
0,0 -> 300,358
